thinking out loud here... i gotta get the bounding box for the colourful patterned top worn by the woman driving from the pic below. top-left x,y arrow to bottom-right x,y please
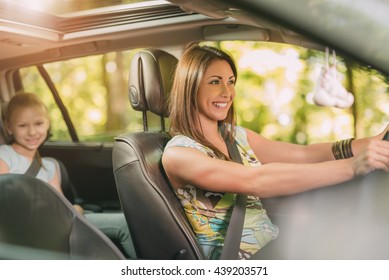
165,126 -> 278,259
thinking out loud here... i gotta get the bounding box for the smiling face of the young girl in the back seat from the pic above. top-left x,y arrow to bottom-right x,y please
7,106 -> 50,151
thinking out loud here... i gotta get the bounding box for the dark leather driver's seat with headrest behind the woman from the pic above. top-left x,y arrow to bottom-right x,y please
113,49 -> 205,260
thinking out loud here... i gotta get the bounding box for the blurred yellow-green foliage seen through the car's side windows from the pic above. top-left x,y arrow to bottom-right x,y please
21,41 -> 389,144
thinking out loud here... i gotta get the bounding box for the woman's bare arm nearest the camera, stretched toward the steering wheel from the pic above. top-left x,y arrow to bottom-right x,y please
162,145 -> 382,198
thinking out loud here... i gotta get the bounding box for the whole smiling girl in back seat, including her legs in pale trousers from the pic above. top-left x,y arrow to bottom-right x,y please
0,93 -> 135,258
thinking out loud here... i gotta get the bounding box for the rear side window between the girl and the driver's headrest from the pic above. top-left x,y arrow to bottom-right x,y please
20,50 -> 160,142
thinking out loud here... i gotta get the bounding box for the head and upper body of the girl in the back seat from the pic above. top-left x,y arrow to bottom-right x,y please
0,93 -> 62,193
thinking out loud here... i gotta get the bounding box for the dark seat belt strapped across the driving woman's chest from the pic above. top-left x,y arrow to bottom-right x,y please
220,136 -> 247,260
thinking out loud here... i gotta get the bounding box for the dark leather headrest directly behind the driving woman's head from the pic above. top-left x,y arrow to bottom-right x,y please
129,49 -> 178,117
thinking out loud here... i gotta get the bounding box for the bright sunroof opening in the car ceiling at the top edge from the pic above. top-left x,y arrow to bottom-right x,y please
0,0 -> 161,16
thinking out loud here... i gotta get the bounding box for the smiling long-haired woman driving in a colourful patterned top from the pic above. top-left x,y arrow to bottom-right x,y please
162,45 -> 389,259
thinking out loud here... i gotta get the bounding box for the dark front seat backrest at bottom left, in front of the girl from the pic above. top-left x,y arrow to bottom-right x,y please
0,174 -> 125,260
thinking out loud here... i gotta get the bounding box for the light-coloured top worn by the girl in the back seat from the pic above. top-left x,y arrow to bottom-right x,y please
0,145 -> 59,183
